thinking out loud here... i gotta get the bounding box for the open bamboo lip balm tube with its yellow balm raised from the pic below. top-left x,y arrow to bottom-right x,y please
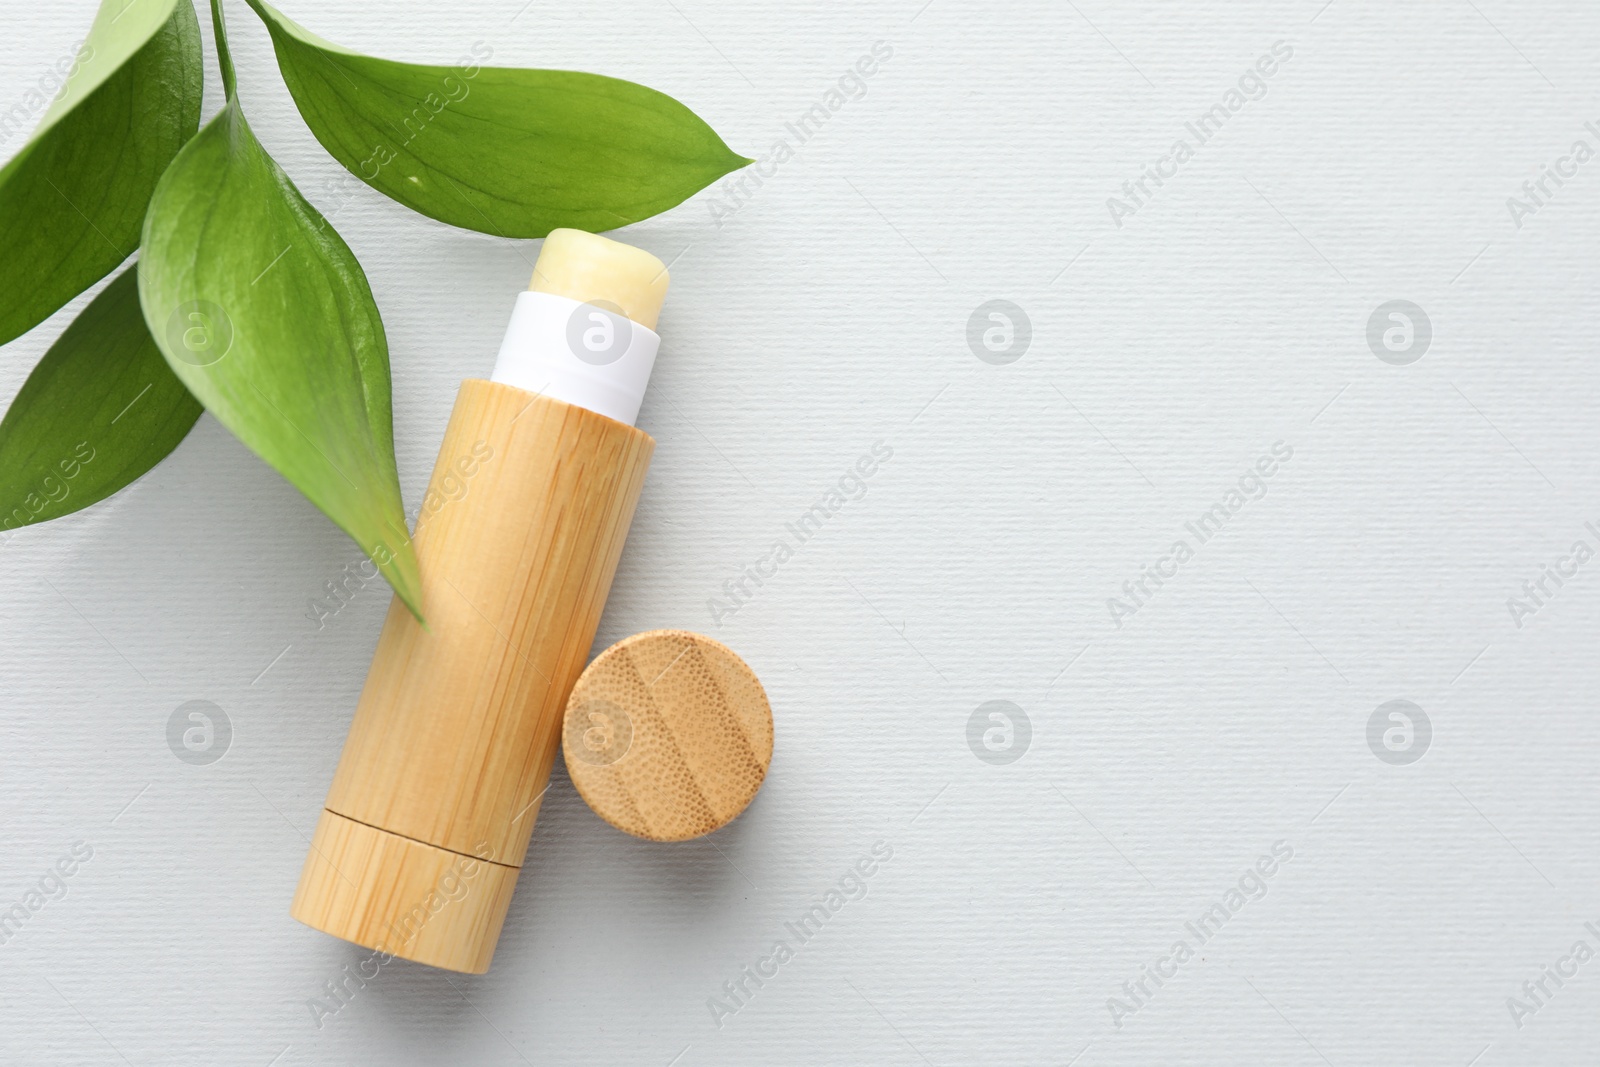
290,230 -> 667,974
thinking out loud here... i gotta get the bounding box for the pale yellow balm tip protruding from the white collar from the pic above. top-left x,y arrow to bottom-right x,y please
528,229 -> 670,330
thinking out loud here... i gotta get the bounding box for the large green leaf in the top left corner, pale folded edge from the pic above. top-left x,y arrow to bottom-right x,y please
0,0 -> 202,344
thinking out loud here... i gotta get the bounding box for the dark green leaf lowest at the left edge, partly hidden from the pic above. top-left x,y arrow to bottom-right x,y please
0,269 -> 200,531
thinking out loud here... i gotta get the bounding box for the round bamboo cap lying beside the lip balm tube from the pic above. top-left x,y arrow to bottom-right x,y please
562,630 -> 773,841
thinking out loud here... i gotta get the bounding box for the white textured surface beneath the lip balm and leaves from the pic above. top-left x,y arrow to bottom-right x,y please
0,0 -> 1600,1067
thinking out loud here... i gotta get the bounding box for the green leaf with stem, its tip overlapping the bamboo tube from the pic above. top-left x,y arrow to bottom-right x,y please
139,0 -> 421,619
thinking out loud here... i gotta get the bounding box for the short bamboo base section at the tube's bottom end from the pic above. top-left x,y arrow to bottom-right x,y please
290,811 -> 518,974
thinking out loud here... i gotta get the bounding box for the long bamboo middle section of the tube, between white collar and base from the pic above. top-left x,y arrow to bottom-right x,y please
326,379 -> 654,867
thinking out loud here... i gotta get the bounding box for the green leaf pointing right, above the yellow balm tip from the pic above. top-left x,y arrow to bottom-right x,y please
248,0 -> 752,237
